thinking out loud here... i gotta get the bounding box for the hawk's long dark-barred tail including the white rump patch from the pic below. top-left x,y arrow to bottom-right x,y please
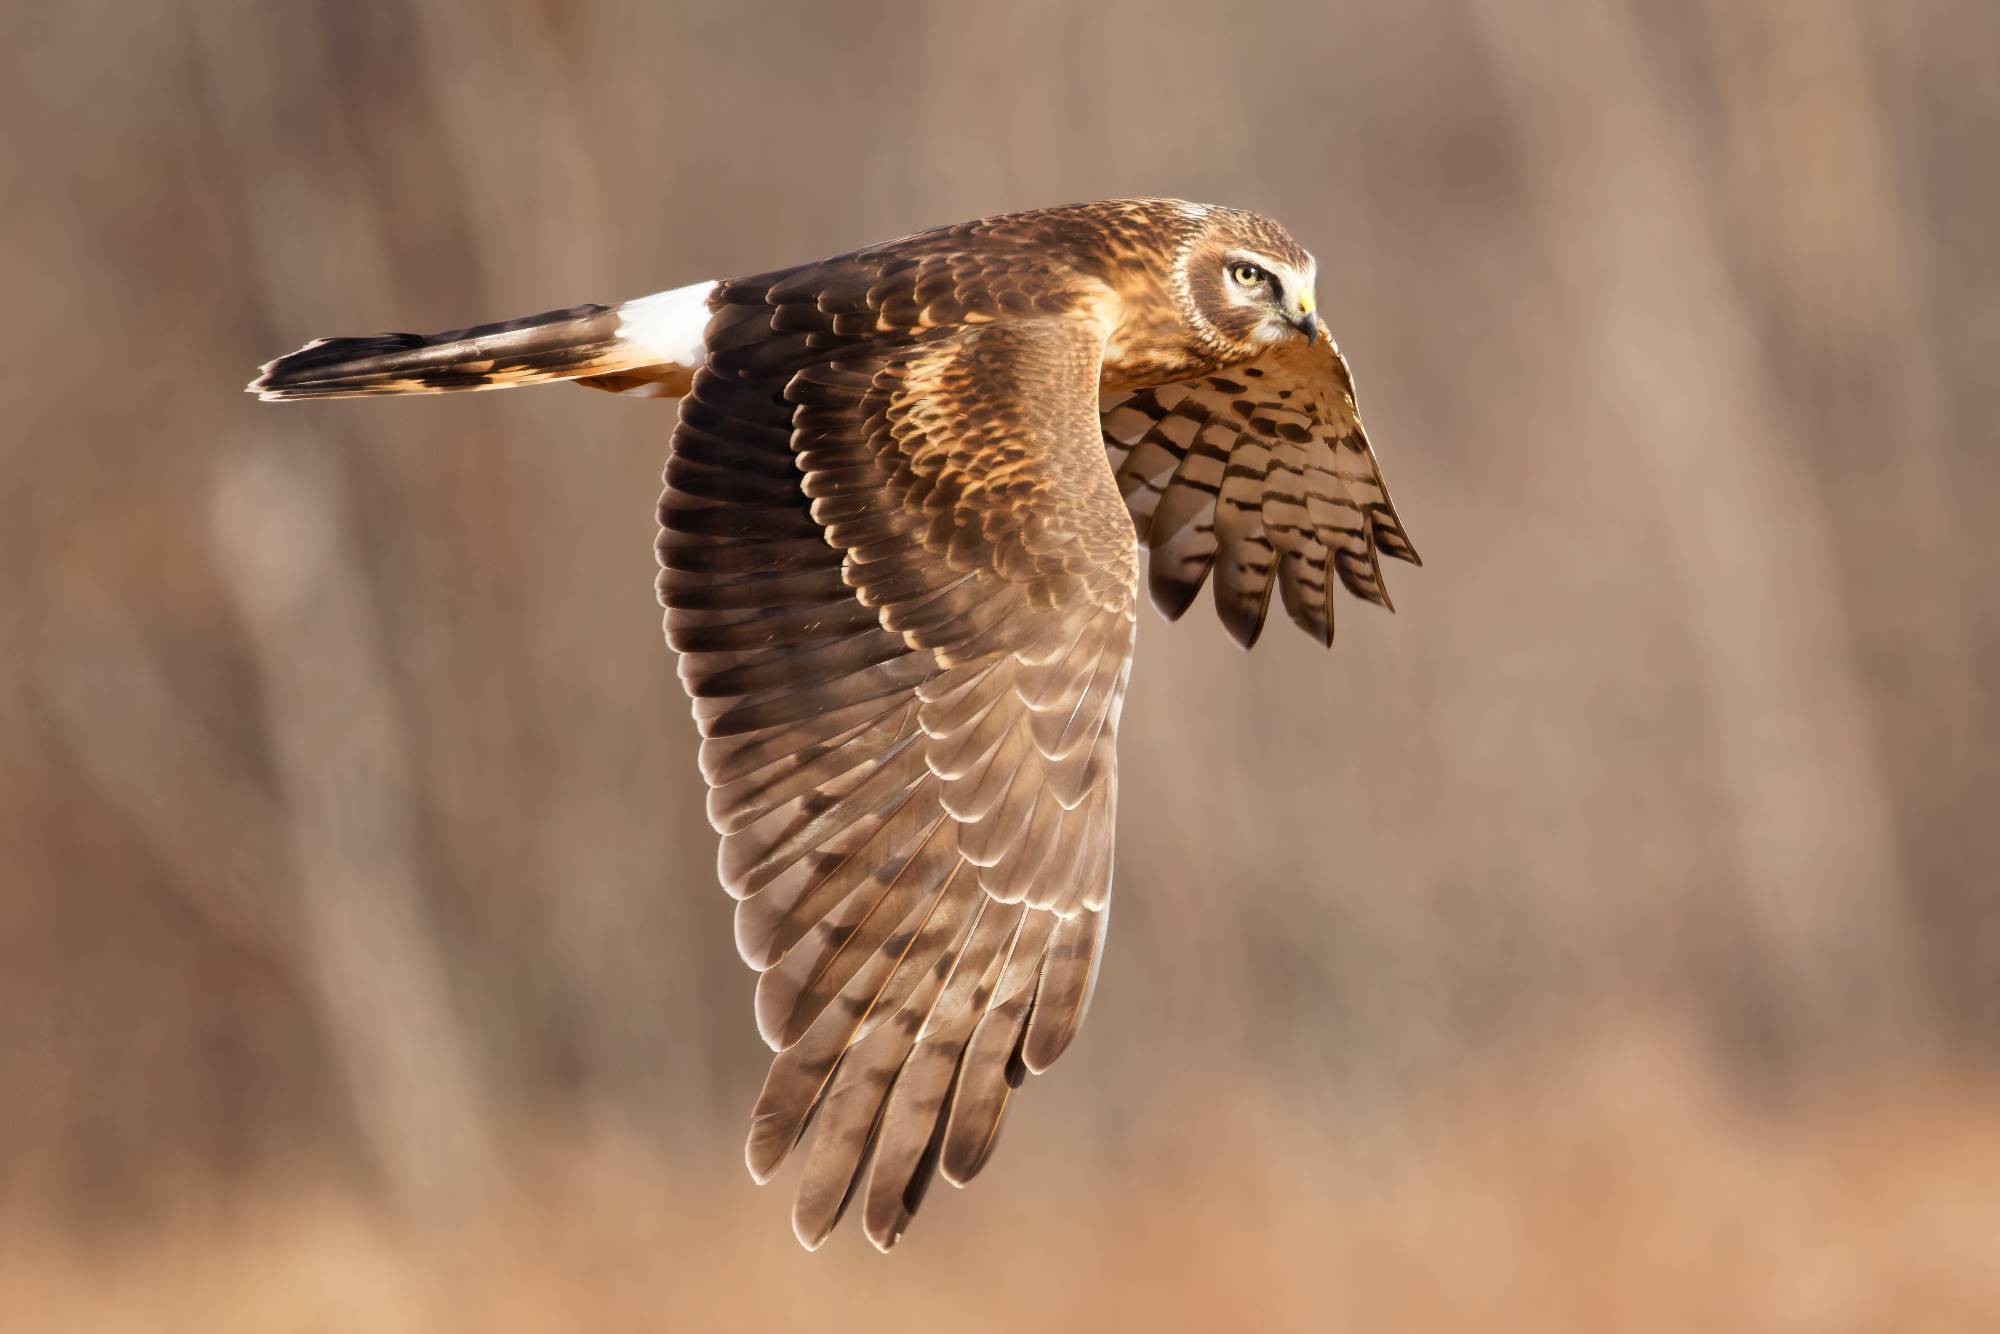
248,282 -> 714,400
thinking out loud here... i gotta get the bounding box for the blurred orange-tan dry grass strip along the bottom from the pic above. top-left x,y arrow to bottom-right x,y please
15,1040 -> 2000,1334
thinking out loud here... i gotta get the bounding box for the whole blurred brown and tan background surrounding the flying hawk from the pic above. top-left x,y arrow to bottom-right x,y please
0,0 -> 2000,1334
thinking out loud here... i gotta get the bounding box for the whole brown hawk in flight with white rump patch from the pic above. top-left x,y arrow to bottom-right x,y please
250,200 -> 1418,1250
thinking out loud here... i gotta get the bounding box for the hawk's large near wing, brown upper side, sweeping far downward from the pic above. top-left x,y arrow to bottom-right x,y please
658,256 -> 1138,1248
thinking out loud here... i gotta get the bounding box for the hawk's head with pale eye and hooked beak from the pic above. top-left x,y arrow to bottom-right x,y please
1176,208 -> 1320,360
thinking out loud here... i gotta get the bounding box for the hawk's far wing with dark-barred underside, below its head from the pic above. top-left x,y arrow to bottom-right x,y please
1102,322 -> 1420,648
